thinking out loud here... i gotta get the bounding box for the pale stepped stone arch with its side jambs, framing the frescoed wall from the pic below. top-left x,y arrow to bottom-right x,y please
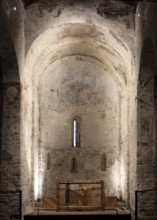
21,15 -> 133,211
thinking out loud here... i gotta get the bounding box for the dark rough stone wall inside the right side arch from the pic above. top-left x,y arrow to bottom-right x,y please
137,41 -> 156,216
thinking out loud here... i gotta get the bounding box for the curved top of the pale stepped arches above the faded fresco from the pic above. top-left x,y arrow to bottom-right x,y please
24,23 -> 132,89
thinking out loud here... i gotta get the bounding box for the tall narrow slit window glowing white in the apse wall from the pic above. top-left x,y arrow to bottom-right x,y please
72,117 -> 80,148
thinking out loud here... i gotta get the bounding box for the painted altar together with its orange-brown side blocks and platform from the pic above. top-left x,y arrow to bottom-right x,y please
24,179 -> 131,220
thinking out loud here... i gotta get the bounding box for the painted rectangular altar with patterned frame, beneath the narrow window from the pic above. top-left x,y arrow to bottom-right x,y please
57,180 -> 105,211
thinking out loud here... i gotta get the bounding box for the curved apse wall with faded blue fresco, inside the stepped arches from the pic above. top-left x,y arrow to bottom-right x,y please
37,55 -> 119,198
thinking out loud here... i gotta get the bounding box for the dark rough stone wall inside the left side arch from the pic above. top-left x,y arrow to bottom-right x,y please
0,2 -> 21,220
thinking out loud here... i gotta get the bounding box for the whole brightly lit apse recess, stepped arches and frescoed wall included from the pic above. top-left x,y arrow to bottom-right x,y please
22,11 -> 131,211
